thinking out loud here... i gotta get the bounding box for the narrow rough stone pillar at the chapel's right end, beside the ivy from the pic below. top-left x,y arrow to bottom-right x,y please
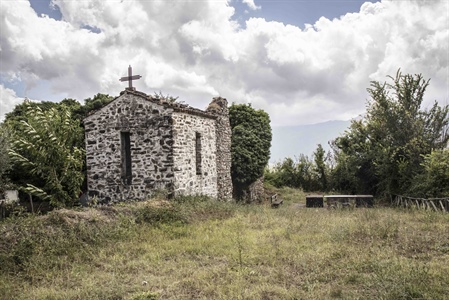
206,97 -> 233,200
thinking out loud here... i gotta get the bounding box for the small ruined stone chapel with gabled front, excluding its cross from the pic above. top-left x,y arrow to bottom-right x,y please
84,85 -> 232,202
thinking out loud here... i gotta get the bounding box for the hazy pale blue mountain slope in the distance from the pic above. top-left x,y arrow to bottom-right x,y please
270,121 -> 351,163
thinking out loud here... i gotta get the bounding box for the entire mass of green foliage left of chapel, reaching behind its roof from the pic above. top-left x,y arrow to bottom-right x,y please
0,93 -> 114,205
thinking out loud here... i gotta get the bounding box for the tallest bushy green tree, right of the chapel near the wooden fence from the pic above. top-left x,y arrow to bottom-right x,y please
333,71 -> 449,194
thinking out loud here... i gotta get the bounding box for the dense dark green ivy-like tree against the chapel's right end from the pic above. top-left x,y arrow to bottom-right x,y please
229,104 -> 271,198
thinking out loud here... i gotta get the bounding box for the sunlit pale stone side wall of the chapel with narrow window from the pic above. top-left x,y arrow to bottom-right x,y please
172,112 -> 217,197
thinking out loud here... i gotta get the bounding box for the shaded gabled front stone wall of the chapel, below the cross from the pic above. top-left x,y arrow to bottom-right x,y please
84,91 -> 173,202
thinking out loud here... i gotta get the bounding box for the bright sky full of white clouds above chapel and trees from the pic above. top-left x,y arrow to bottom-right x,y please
0,0 -> 449,132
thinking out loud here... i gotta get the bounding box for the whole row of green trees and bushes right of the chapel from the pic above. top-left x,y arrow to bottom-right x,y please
265,70 -> 449,198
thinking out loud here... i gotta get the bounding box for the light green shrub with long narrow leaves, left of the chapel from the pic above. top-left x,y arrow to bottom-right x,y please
7,103 -> 84,206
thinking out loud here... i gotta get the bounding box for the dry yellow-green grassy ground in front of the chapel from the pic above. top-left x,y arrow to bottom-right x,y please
0,189 -> 449,299
